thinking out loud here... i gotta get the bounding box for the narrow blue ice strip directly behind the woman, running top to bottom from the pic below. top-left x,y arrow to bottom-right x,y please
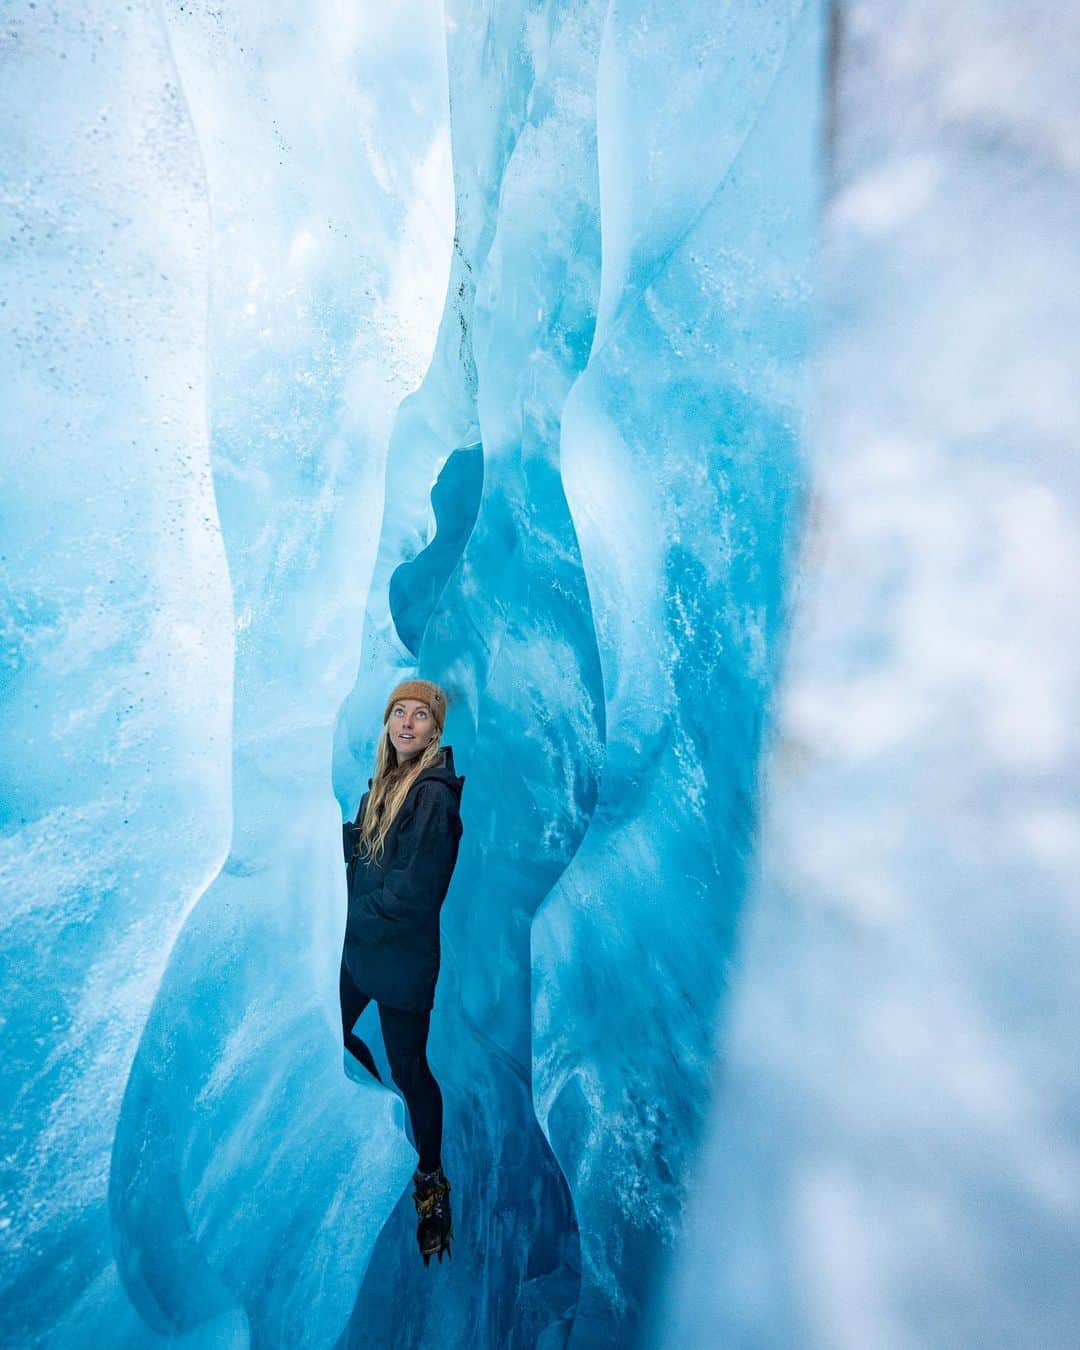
335,4 -> 603,1347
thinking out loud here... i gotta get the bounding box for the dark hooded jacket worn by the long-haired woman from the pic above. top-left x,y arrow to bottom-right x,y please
342,745 -> 464,1011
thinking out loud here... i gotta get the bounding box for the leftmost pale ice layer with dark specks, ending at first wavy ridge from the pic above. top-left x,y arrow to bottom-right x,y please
0,4 -> 234,1346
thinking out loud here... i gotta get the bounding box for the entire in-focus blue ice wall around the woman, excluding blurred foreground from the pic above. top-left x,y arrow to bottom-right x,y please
3,0 -> 824,1350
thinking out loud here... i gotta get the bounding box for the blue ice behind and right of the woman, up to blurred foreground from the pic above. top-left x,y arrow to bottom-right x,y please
338,5 -> 822,1346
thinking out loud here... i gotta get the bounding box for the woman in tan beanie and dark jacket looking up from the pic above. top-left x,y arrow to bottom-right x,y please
340,679 -> 464,1265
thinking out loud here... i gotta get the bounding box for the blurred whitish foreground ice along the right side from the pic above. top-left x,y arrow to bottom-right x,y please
662,3 -> 1080,1350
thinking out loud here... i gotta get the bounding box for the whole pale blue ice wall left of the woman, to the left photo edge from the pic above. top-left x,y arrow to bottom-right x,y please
0,4 -> 452,1346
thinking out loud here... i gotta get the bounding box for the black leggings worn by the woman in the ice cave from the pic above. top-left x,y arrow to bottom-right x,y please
339,961 -> 443,1172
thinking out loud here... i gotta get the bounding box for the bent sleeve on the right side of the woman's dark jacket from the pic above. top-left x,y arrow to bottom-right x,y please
350,783 -> 462,942
